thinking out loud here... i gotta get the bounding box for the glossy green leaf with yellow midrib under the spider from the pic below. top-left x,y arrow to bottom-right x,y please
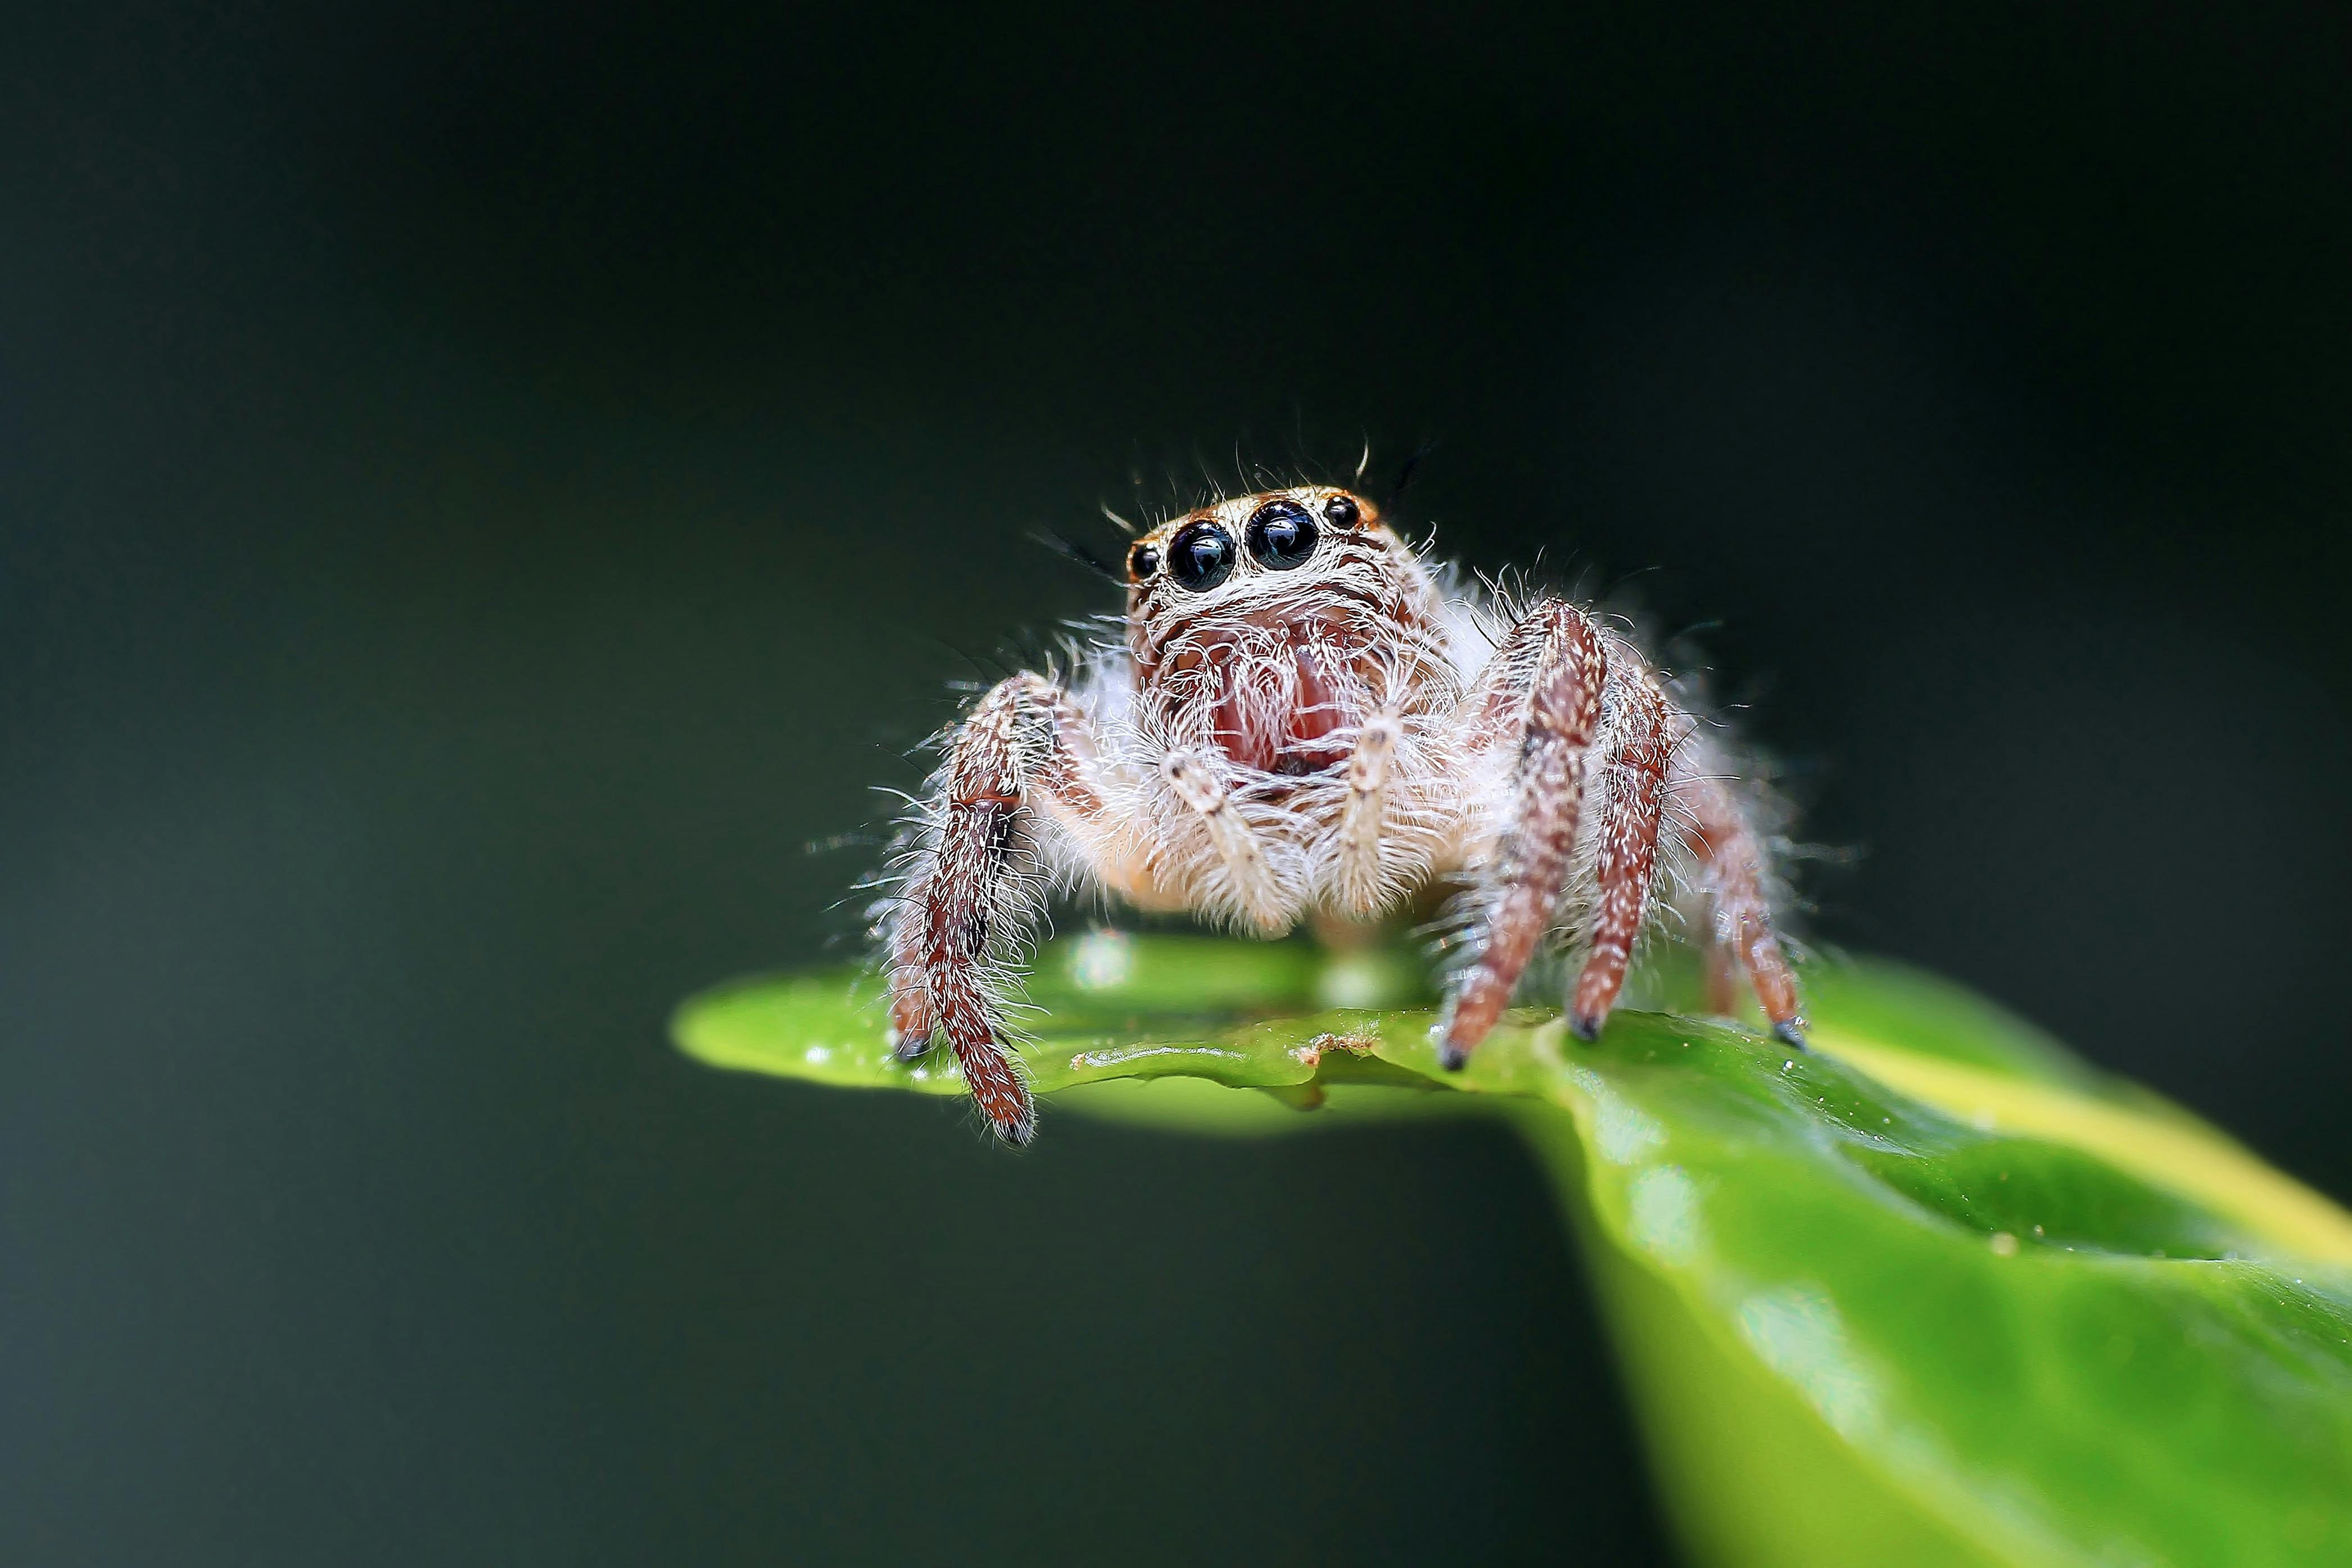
675,933 -> 2352,1564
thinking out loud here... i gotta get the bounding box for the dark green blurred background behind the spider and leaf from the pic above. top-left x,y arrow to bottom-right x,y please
0,0 -> 2352,1564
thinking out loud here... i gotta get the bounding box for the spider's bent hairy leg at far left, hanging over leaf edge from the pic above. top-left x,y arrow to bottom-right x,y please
882,674 -> 1110,1143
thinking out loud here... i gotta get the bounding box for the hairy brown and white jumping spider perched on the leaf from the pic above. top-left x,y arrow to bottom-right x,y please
875,484 -> 1804,1143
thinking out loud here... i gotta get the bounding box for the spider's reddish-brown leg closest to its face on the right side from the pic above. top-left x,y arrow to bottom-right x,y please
1437,602 -> 1609,1069
